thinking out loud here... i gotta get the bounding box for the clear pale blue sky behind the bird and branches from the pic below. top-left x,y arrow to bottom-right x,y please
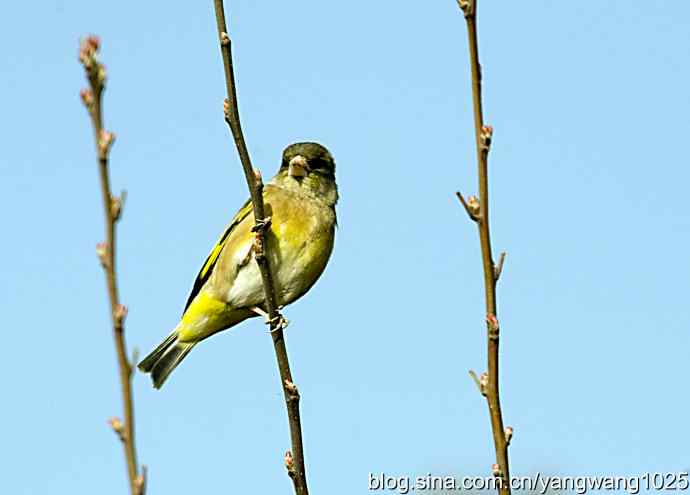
0,0 -> 690,495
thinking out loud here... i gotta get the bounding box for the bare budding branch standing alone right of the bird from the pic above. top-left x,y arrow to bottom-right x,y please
457,0 -> 513,495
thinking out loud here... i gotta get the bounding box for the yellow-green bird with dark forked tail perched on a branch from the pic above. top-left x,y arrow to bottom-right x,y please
138,142 -> 338,389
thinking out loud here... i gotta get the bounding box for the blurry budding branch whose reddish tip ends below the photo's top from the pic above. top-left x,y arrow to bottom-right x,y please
79,36 -> 146,495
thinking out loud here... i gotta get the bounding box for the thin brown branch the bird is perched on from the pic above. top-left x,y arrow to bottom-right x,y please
208,4 -> 309,495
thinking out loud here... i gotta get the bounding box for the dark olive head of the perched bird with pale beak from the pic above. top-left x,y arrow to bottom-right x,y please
278,143 -> 338,205
